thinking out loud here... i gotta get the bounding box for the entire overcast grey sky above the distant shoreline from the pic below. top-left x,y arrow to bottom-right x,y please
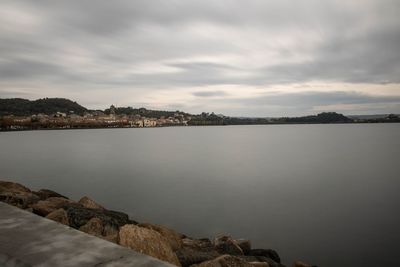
0,0 -> 400,117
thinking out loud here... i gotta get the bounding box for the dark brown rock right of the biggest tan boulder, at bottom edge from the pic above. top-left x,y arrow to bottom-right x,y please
175,247 -> 221,267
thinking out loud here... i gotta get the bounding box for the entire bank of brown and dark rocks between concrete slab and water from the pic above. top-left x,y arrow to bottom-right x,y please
0,181 -> 318,267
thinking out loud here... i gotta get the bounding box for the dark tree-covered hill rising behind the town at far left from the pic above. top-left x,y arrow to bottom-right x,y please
0,98 -> 87,116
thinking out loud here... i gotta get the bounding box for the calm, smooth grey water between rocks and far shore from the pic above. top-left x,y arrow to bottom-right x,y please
0,124 -> 400,267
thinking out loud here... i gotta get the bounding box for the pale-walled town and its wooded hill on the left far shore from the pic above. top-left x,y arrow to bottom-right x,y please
0,99 -> 191,130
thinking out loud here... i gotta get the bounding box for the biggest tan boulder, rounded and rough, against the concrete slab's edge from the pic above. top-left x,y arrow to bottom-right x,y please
119,224 -> 181,266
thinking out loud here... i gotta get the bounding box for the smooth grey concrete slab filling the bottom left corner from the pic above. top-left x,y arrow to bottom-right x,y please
0,202 -> 173,267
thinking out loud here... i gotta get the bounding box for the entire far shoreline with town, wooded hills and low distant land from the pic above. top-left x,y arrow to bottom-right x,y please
0,98 -> 400,131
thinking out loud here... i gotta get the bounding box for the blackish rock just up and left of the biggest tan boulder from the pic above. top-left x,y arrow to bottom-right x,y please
63,203 -> 136,233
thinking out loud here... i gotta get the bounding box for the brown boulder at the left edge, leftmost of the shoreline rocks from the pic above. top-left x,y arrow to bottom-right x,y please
0,181 -> 39,209
